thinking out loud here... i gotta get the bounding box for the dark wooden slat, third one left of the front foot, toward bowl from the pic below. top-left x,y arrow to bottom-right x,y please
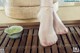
17,30 -> 28,53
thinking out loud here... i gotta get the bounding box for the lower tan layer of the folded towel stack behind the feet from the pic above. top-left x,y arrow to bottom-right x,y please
5,6 -> 40,19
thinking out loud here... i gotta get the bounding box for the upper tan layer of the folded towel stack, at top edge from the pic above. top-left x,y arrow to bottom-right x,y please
6,0 -> 57,6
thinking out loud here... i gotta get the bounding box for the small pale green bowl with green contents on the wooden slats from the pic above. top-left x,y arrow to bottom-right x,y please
4,26 -> 23,39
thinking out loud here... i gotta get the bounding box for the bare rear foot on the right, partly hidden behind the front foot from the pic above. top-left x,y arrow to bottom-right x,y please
53,11 -> 68,34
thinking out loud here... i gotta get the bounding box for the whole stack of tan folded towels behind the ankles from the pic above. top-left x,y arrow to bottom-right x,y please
5,0 -> 58,19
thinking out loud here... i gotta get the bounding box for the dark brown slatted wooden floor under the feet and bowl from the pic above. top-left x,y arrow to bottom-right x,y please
0,25 -> 80,53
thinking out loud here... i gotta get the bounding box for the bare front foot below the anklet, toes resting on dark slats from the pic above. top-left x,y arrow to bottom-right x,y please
38,8 -> 58,47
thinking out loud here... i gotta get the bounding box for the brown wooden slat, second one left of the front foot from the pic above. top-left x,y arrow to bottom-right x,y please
25,29 -> 33,53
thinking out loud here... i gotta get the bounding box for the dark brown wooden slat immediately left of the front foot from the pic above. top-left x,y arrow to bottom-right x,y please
31,29 -> 38,53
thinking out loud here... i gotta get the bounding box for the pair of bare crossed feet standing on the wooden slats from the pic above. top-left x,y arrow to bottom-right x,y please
38,7 -> 68,47
